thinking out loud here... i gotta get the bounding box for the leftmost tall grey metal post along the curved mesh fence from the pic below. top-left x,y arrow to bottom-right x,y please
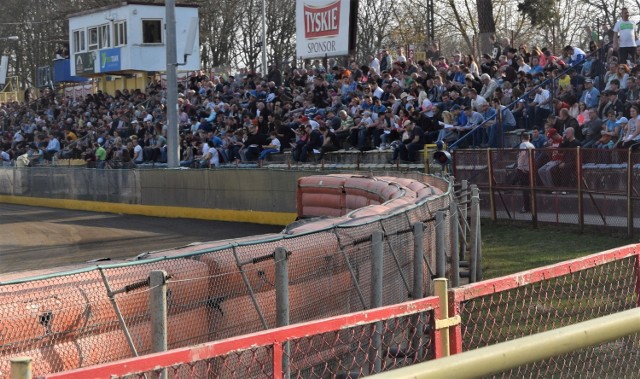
149,270 -> 167,379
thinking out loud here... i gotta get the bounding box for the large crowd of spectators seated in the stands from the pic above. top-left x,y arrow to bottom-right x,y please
0,13 -> 640,168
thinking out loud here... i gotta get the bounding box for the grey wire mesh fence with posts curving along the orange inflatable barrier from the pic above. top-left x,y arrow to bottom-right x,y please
0,173 -> 480,377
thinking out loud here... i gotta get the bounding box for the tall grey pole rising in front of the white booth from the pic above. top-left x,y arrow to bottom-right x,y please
165,0 -> 180,168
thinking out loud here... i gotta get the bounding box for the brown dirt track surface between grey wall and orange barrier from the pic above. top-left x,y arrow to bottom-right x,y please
0,204 -> 284,274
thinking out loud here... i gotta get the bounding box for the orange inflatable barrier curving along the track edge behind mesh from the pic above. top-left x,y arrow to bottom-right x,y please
0,174 -> 451,377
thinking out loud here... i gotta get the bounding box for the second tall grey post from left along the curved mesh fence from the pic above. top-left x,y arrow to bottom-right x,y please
274,247 -> 290,378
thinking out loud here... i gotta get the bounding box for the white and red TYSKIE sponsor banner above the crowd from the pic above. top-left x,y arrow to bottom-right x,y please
296,0 -> 350,59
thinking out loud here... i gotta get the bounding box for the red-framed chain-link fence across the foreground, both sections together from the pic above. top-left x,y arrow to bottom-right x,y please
41,245 -> 640,379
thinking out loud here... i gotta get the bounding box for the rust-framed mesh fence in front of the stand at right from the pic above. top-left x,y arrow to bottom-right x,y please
454,148 -> 640,235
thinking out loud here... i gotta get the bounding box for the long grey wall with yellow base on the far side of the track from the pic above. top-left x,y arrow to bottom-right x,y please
0,167 -> 309,225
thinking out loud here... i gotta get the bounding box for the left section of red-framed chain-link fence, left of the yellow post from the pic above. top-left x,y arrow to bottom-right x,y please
46,297 -> 439,379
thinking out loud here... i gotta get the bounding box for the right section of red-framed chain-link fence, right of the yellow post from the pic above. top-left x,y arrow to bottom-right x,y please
452,247 -> 640,378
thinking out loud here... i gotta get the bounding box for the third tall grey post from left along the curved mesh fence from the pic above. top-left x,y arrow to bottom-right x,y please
369,230 -> 384,374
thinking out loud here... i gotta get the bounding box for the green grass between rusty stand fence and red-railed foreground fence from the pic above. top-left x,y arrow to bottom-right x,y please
482,220 -> 637,279
